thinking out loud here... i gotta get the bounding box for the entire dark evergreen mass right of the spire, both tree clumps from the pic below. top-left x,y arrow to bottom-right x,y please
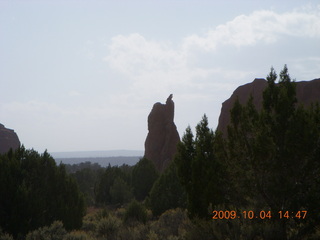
176,66 -> 320,239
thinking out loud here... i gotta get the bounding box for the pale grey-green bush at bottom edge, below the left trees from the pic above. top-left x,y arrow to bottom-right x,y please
26,221 -> 67,240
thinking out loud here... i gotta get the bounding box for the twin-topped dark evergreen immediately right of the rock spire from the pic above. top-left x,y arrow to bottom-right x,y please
175,115 -> 224,218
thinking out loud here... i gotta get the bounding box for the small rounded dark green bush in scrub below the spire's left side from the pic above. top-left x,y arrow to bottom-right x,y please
124,200 -> 148,223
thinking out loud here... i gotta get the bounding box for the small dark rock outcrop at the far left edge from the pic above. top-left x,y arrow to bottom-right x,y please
0,123 -> 20,154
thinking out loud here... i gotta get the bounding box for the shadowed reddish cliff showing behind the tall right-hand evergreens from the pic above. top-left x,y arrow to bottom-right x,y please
217,78 -> 320,136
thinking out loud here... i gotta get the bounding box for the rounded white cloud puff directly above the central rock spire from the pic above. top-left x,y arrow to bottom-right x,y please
104,33 -> 218,100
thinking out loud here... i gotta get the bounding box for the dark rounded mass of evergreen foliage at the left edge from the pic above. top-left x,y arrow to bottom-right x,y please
0,146 -> 85,236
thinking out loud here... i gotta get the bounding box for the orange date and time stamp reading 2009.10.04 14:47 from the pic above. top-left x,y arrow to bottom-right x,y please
212,210 -> 307,219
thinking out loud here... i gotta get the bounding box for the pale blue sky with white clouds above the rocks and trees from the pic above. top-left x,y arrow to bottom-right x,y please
0,0 -> 320,152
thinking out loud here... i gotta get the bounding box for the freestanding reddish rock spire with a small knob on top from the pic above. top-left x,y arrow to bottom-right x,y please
144,94 -> 180,172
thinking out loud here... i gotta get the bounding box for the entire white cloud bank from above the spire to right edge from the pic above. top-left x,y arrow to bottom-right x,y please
105,5 -> 320,91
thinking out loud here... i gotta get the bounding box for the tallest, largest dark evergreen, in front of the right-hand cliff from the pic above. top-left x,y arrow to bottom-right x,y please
225,66 -> 320,239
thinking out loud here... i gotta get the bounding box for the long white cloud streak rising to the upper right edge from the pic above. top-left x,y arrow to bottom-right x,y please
183,8 -> 320,51
